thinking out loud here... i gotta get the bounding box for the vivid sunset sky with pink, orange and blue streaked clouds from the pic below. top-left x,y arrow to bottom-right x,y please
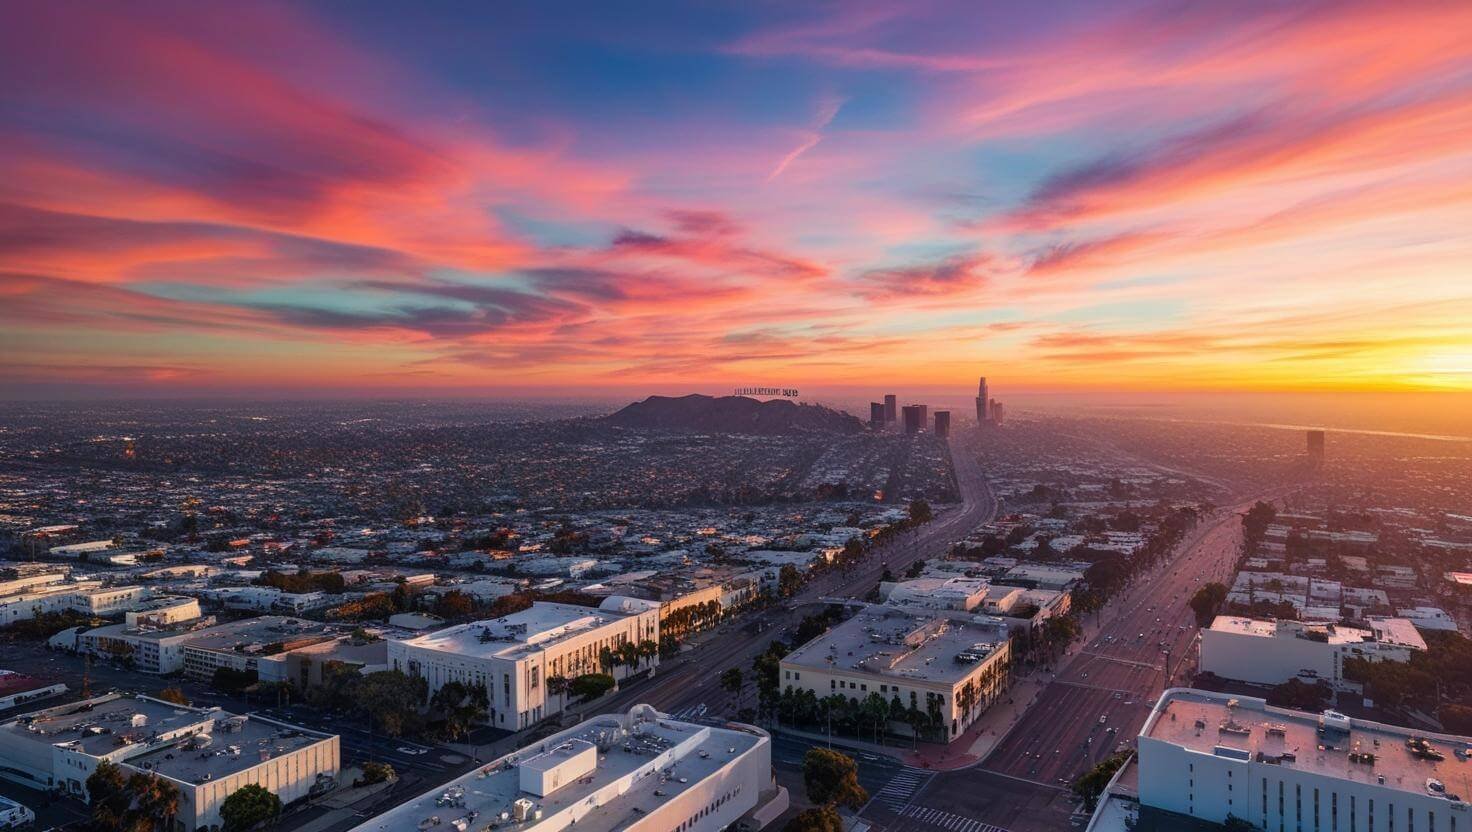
0,0 -> 1472,396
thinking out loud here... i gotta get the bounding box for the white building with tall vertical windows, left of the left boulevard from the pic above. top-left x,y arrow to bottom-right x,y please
389,596 -> 659,730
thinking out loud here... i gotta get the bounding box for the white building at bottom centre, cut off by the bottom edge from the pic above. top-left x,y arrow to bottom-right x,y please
352,705 -> 786,832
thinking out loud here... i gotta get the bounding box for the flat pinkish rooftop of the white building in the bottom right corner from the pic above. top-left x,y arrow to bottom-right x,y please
1141,689 -> 1472,800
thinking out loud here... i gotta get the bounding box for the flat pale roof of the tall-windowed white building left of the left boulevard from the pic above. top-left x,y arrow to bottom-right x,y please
403,601 -> 626,658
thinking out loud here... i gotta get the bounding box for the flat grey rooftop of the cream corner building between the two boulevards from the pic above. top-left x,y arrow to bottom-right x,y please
782,607 -> 1007,683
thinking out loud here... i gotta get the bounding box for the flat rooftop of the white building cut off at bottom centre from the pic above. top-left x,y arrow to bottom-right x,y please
353,708 -> 765,832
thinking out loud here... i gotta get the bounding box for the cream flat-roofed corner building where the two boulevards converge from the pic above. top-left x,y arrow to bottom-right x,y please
780,607 -> 1011,741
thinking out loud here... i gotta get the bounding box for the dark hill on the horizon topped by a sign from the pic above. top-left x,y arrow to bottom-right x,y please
608,393 -> 864,434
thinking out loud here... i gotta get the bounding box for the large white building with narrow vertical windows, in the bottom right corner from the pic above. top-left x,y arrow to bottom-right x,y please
1138,689 -> 1472,832
